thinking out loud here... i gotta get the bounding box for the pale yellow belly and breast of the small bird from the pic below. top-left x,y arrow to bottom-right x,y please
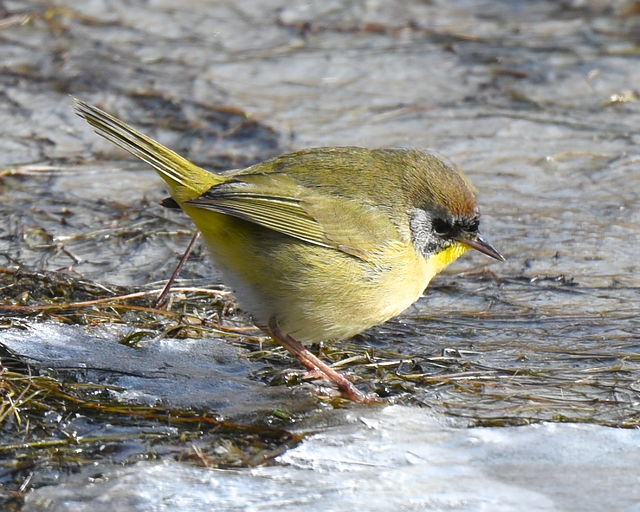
190,209 -> 432,342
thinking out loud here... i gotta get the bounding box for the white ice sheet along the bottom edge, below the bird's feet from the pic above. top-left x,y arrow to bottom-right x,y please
25,406 -> 640,512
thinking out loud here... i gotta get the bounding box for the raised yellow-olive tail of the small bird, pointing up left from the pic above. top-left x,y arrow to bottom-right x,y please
74,98 -> 222,202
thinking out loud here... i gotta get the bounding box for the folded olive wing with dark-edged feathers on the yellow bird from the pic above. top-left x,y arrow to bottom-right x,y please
186,173 -> 400,261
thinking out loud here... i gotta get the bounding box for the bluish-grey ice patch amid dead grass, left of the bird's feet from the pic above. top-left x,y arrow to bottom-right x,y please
0,322 -> 291,417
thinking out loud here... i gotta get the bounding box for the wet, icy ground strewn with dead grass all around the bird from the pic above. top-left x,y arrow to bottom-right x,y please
0,0 -> 640,511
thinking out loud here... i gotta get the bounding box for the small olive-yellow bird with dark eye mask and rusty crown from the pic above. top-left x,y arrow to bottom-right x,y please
76,100 -> 504,401
